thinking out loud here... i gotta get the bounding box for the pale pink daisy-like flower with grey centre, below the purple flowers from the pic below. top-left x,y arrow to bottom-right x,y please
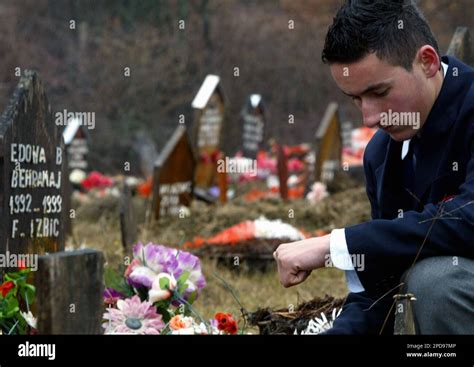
102,296 -> 165,334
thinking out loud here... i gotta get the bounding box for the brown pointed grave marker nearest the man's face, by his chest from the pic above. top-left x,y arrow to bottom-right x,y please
314,102 -> 342,182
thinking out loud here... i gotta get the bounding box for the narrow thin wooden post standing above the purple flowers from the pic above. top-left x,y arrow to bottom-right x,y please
119,182 -> 138,255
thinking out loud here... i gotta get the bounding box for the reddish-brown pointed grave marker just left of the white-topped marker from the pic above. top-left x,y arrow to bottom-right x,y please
153,126 -> 196,219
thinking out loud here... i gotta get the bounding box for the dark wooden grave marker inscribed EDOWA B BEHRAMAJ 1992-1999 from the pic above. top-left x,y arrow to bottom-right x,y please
0,71 -> 68,253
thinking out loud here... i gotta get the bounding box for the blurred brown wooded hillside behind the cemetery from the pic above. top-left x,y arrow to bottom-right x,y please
0,0 -> 474,174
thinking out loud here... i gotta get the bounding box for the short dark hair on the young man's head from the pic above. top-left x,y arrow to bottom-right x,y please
322,0 -> 440,71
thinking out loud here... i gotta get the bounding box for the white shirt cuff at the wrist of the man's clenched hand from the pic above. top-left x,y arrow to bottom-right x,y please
329,228 -> 365,293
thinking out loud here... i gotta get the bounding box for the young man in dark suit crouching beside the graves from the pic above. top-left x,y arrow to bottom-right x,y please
274,0 -> 474,334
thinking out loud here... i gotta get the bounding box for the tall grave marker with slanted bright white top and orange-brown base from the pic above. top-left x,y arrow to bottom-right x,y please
192,75 -> 225,188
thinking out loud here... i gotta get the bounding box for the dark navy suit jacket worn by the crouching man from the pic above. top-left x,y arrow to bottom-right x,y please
328,57 -> 474,333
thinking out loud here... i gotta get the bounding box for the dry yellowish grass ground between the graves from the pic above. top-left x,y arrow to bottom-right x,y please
67,180 -> 370,332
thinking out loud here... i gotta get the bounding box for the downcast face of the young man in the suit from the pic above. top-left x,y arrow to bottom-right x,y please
331,53 -> 434,141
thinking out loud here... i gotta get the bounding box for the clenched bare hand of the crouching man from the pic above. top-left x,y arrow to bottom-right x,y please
273,235 -> 331,288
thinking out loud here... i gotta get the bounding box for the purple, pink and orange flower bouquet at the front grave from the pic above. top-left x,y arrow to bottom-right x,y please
103,243 -> 237,334
